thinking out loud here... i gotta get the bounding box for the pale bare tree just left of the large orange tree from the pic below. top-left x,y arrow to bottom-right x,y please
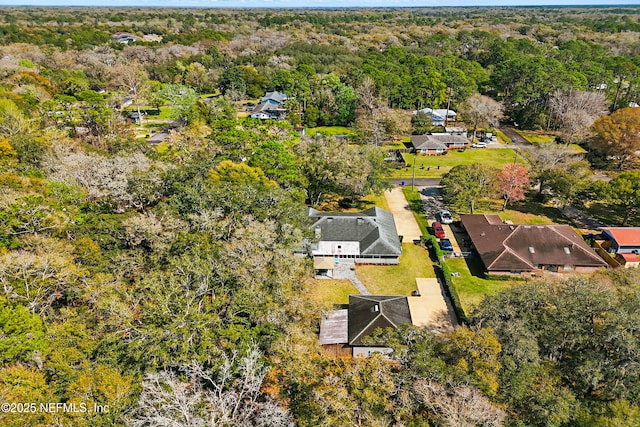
549,90 -> 607,144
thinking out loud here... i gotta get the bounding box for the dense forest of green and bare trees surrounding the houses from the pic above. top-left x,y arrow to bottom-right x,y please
0,6 -> 640,427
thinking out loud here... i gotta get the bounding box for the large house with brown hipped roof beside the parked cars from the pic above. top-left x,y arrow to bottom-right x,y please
460,215 -> 607,275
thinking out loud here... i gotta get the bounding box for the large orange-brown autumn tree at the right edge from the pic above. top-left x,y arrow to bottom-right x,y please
589,107 -> 640,170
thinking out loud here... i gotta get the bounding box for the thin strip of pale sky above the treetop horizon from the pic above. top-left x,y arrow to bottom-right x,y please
0,0 -> 640,8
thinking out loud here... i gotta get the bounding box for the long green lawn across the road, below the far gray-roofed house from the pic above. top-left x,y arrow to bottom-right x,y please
391,148 -> 526,178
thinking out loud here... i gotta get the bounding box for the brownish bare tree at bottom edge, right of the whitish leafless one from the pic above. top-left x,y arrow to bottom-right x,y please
413,380 -> 507,427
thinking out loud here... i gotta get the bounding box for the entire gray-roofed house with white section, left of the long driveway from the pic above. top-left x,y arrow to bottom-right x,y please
309,207 -> 402,264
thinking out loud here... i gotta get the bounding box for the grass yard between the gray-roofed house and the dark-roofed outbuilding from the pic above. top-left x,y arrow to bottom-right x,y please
356,243 -> 436,296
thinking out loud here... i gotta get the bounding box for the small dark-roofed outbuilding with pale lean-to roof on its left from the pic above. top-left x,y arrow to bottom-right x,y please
320,295 -> 412,357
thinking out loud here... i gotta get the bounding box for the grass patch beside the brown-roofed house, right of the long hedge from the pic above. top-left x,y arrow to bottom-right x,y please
446,258 -> 513,315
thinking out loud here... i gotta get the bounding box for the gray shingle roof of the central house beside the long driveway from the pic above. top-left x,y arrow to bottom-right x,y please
309,206 -> 402,256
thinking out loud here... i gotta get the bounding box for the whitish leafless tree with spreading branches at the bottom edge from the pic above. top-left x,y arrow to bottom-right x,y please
132,346 -> 294,427
